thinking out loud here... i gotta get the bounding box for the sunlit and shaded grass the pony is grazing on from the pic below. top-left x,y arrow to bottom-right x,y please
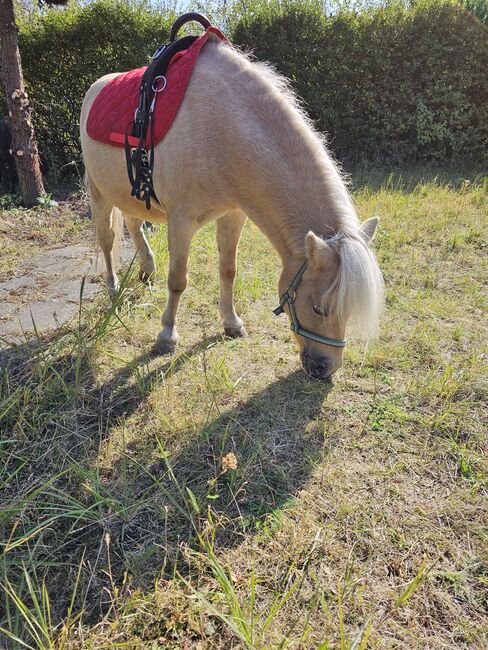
0,172 -> 488,650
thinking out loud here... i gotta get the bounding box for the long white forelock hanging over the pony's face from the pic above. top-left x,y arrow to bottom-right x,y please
323,232 -> 384,339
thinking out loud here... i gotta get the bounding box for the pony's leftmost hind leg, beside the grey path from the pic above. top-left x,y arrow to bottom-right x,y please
87,177 -> 120,296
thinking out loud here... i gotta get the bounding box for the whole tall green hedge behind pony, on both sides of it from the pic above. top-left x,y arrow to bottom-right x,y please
9,0 -> 488,172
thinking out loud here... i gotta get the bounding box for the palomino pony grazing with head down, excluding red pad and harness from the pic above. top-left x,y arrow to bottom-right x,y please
81,36 -> 383,378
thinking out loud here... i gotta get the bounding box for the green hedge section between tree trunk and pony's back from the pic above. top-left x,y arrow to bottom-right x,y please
16,0 -> 171,173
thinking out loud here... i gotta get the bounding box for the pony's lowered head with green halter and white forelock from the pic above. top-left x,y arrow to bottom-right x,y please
279,218 -> 383,379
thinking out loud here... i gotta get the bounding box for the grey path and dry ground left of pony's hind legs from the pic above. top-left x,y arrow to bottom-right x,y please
0,192 -> 139,341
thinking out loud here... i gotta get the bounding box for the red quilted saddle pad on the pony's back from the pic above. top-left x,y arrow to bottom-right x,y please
87,27 -> 227,148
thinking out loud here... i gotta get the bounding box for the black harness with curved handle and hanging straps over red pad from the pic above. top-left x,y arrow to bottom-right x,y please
125,12 -> 210,210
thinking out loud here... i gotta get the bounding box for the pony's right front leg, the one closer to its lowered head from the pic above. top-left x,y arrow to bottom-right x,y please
217,212 -> 247,338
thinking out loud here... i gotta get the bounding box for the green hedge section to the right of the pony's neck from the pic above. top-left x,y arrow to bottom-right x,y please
234,1 -> 488,162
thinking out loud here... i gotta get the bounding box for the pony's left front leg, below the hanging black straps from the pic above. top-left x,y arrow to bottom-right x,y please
156,216 -> 196,354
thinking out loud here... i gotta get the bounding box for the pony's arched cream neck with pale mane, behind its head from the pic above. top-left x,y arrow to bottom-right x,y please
227,53 -> 359,259
